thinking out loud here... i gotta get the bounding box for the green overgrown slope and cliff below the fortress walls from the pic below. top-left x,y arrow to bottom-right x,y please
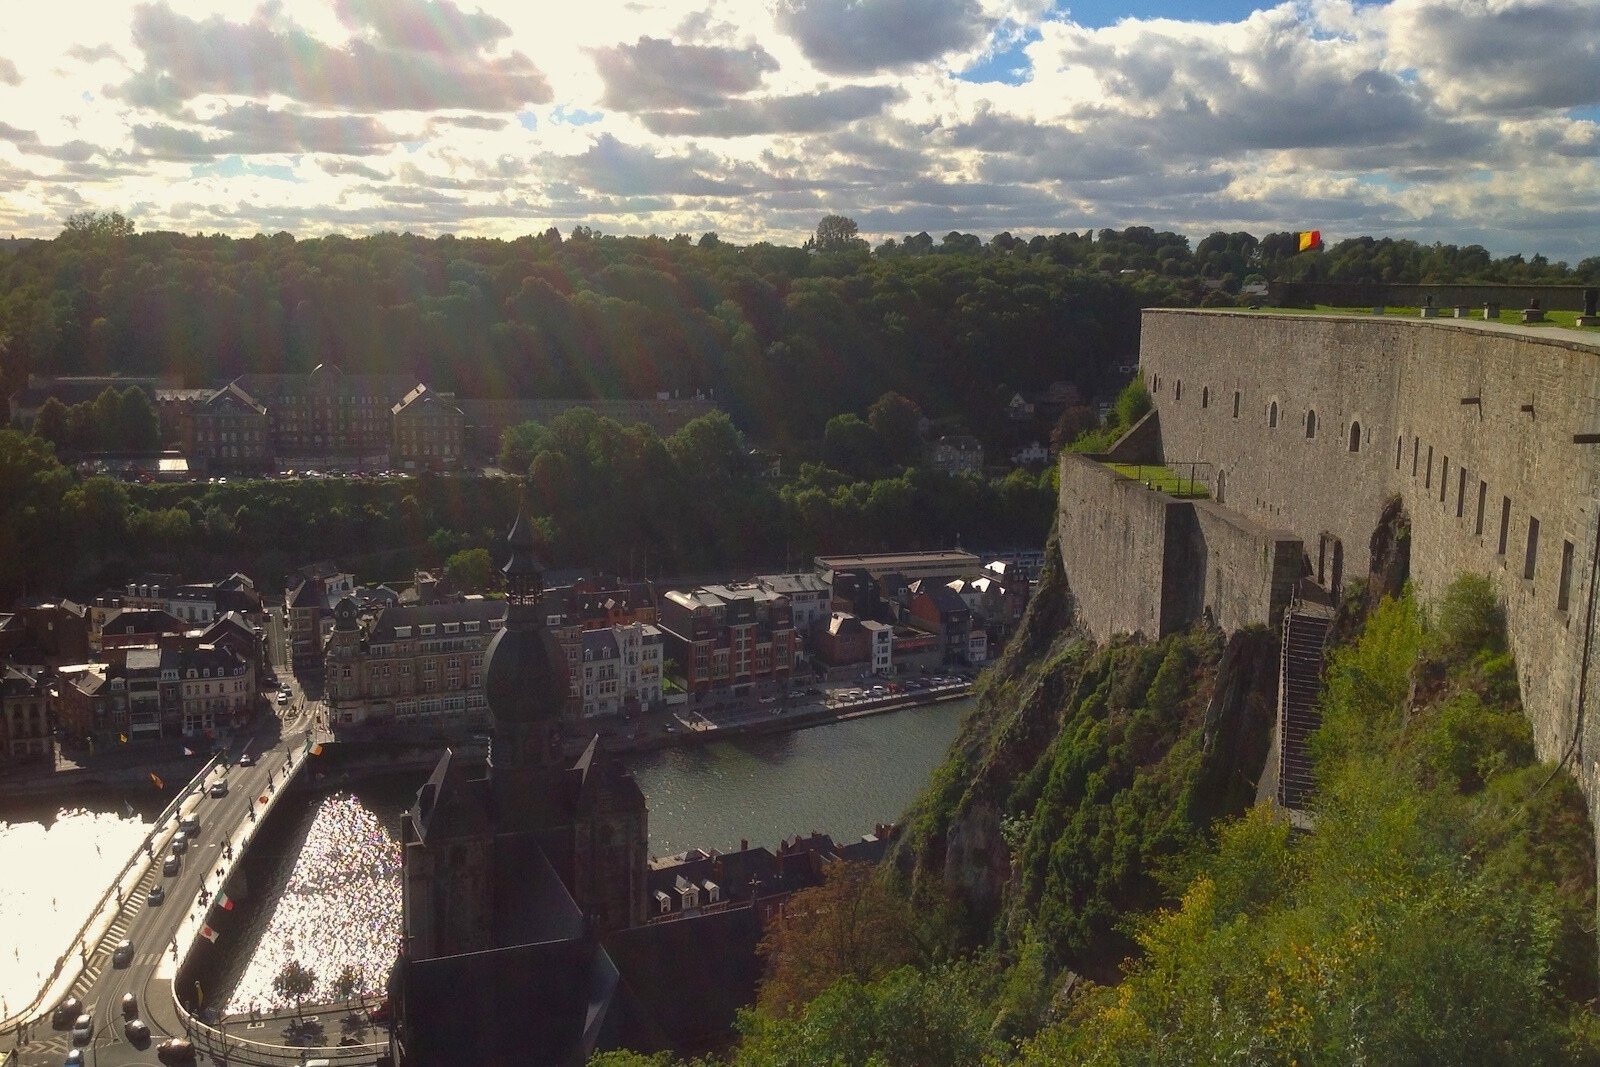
600,547 -> 1600,1067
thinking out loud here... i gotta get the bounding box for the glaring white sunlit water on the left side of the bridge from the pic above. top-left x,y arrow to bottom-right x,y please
0,809 -> 150,1017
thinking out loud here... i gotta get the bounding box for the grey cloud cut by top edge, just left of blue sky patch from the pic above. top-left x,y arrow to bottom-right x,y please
776,0 -> 992,74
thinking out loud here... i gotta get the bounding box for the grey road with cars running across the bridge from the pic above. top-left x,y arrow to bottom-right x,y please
6,721 -> 316,1067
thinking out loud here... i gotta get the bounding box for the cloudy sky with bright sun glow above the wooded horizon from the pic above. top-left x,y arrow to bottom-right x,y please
0,0 -> 1600,255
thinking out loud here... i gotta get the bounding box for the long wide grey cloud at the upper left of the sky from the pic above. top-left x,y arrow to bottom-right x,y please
115,3 -> 550,112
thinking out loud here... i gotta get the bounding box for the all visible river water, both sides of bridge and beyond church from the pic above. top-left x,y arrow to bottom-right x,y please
0,699 -> 971,1011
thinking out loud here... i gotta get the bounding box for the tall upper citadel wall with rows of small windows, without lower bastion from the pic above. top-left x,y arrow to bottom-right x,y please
1132,310 -> 1600,797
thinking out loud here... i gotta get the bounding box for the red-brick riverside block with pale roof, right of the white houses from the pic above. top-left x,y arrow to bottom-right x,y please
659,582 -> 795,705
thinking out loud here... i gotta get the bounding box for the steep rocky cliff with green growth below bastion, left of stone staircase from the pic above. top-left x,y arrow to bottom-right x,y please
896,524 -> 1278,969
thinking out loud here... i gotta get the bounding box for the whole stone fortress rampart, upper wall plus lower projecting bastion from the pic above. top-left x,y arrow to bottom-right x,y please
1059,310 -> 1600,801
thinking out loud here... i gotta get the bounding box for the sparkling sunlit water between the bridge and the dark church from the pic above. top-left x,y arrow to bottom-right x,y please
227,793 -> 400,1013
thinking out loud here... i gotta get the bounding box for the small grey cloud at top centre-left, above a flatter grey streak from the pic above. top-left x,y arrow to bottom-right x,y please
592,37 -> 778,110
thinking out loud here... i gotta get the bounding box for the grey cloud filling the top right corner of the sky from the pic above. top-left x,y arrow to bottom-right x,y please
1390,0 -> 1600,112
